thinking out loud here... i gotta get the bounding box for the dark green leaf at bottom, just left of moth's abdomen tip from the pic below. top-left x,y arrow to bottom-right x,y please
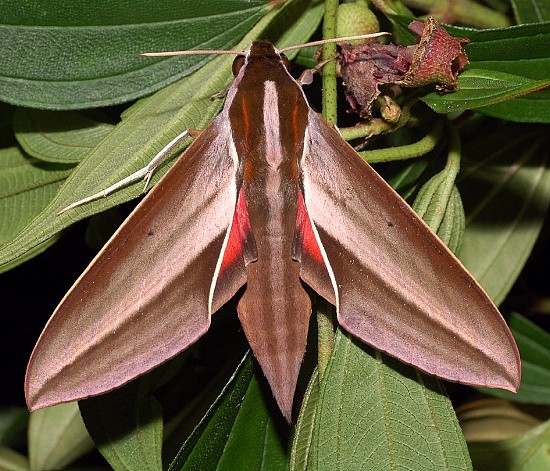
169,354 -> 286,471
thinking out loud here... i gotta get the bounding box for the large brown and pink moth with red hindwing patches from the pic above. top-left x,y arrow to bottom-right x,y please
25,37 -> 521,421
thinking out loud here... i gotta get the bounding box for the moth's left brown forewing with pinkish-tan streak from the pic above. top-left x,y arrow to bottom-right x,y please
25,116 -> 246,410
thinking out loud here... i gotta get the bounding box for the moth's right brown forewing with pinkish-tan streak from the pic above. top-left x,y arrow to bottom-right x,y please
301,112 -> 521,390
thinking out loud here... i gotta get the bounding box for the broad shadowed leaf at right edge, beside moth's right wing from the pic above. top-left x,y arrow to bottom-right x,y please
458,124 -> 550,304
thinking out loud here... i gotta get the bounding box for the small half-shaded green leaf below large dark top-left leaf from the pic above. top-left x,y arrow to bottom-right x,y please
13,108 -> 114,164
